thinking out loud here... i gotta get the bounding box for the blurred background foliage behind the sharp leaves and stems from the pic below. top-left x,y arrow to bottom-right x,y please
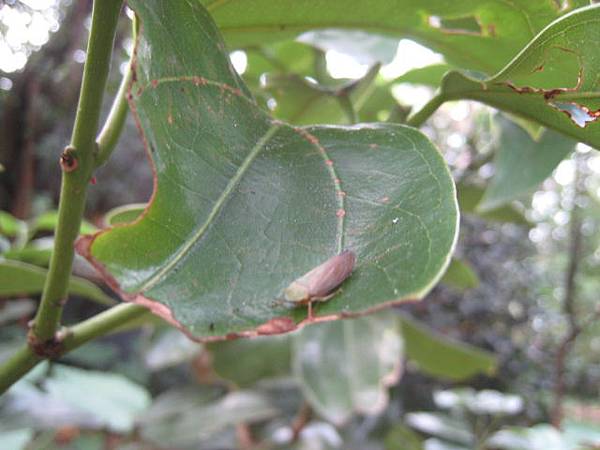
0,0 -> 600,450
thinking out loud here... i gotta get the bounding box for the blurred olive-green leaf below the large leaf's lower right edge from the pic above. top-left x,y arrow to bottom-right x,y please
402,316 -> 497,381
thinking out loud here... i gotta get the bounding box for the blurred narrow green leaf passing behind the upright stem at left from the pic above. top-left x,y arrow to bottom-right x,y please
0,261 -> 115,305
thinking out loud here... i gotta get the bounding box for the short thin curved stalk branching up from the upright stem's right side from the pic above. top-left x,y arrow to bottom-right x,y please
96,16 -> 138,167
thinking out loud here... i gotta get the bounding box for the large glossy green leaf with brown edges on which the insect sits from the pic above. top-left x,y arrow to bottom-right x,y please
78,0 -> 458,338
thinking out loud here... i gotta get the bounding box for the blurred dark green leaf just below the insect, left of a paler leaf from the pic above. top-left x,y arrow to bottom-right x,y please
208,336 -> 291,387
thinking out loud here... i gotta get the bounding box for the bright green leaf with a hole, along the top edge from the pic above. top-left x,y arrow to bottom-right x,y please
201,0 -> 589,74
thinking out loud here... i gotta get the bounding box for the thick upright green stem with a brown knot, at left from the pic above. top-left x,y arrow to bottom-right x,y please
31,0 -> 122,343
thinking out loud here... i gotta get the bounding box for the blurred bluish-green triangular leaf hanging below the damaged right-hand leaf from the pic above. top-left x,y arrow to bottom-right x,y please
477,116 -> 576,212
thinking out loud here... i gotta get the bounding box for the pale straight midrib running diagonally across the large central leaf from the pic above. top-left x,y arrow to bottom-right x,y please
141,124 -> 282,290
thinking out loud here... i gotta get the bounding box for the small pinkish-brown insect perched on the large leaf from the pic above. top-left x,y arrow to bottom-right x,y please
283,250 -> 356,320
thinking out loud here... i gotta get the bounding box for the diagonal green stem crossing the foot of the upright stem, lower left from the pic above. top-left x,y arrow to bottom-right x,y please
0,303 -> 148,395
